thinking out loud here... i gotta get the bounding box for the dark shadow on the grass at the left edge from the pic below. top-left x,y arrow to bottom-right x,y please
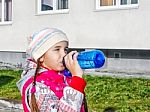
0,76 -> 14,87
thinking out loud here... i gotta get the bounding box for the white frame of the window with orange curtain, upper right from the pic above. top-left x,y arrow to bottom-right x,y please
94,0 -> 139,11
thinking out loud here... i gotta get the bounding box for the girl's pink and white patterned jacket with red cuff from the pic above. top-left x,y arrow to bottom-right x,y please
17,60 -> 86,112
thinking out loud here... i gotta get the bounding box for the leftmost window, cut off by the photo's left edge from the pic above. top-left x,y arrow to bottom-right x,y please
0,0 -> 12,23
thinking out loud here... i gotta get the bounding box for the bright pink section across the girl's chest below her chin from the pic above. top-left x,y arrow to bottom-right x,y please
36,70 -> 71,99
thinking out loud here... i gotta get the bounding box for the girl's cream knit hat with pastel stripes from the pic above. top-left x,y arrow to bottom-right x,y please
26,28 -> 68,61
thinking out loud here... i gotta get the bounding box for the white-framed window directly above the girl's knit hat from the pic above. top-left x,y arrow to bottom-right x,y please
38,0 -> 68,13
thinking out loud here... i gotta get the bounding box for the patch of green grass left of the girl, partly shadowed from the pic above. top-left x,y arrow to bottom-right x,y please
0,70 -> 21,100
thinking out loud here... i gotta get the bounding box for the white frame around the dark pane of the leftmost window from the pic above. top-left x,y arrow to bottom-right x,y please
0,0 -> 13,25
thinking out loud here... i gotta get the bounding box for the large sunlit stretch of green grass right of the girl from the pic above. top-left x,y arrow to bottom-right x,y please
85,76 -> 150,112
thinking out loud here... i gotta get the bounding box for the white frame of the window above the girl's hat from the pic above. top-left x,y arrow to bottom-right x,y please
36,0 -> 69,15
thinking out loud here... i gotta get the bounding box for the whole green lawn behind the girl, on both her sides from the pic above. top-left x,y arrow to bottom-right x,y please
0,70 -> 150,112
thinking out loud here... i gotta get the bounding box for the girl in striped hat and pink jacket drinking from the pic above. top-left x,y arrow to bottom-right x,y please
17,28 -> 87,112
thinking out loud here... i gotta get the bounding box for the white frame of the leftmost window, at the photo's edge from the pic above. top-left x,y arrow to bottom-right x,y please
0,0 -> 13,25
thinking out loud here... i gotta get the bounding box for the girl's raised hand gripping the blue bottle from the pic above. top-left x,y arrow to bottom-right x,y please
65,51 -> 83,77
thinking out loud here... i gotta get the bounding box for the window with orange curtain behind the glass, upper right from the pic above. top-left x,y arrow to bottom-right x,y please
96,0 -> 139,9
